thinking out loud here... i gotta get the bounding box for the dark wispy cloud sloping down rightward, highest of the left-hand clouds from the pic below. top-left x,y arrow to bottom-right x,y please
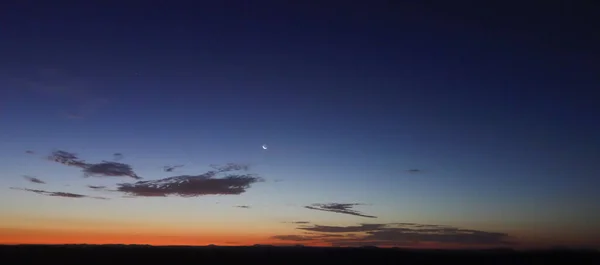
48,150 -> 141,179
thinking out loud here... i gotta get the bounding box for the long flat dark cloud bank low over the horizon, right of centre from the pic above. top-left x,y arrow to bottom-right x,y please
273,223 -> 515,246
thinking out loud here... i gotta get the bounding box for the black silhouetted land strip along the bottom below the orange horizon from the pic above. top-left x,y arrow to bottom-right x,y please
0,245 -> 600,265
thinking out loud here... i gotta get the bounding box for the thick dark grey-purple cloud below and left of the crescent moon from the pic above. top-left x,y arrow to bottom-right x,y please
117,168 -> 263,197
